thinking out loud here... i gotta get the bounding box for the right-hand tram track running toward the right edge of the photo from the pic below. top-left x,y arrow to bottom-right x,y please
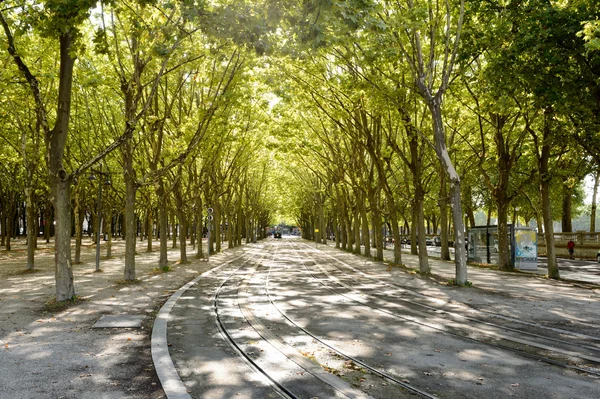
290,244 -> 600,376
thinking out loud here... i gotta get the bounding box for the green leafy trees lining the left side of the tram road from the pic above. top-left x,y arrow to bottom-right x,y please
0,0 -> 282,301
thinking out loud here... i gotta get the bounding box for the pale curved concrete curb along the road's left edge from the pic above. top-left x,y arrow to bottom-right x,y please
151,255 -> 244,399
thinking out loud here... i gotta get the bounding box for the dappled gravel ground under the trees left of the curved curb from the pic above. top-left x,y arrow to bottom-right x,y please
0,240 -> 226,399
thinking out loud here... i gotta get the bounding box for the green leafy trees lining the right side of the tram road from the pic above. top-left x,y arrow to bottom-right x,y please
281,0 -> 600,284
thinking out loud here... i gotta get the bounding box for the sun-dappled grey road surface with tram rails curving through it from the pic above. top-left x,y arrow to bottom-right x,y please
163,237 -> 600,399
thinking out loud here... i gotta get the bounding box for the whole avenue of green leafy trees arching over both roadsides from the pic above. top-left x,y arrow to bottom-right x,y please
0,0 -> 600,301
